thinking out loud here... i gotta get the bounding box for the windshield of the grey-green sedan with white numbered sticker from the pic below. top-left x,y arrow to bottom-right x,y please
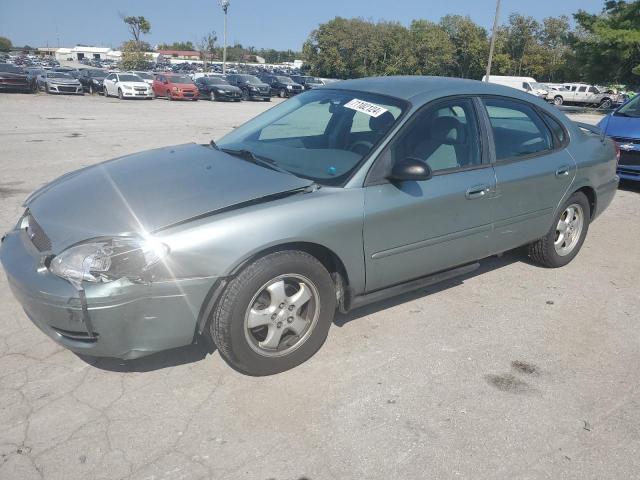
217,89 -> 406,185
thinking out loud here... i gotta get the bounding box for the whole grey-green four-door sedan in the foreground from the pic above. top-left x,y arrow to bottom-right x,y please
0,76 -> 618,375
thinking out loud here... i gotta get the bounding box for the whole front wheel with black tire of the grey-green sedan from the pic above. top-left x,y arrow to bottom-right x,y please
208,251 -> 336,376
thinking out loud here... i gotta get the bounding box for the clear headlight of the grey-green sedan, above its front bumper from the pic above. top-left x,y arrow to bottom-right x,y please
49,237 -> 169,286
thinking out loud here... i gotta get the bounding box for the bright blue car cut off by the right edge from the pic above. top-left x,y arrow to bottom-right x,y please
598,95 -> 640,182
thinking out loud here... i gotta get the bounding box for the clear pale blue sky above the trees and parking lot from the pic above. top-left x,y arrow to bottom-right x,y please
0,0 -> 604,50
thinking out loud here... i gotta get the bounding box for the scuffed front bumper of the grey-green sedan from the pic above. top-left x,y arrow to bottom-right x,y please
0,230 -> 216,359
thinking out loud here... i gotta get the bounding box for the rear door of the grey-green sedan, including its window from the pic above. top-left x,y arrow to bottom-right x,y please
482,97 -> 576,253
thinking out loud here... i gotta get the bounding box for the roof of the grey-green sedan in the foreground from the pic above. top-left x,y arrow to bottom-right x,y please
326,75 -> 552,101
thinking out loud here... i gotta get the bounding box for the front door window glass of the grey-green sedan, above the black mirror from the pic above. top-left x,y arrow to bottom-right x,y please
391,98 -> 482,172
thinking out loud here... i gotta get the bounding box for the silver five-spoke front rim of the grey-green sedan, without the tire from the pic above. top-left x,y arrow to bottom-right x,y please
244,274 -> 320,357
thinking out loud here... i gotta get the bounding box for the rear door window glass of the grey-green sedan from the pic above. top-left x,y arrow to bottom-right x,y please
484,98 -> 553,161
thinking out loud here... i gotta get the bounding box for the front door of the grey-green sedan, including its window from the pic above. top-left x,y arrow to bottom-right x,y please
364,98 -> 495,291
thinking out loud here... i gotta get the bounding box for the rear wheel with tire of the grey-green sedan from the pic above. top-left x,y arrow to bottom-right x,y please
529,192 -> 591,268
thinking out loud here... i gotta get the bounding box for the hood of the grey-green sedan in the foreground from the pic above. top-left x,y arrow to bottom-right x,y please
25,144 -> 313,252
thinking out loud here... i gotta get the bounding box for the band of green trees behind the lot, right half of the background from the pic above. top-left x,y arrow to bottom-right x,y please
302,0 -> 640,84
